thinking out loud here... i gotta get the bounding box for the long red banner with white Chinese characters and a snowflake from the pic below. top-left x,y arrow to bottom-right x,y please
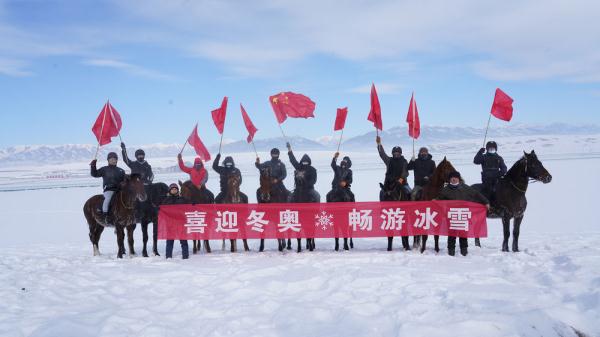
158,200 -> 487,240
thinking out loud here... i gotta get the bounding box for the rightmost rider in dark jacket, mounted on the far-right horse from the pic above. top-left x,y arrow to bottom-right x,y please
473,141 -> 506,201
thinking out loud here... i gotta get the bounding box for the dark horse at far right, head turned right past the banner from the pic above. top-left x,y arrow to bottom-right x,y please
472,150 -> 552,252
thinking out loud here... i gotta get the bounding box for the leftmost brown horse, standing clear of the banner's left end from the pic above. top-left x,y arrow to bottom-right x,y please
83,174 -> 147,259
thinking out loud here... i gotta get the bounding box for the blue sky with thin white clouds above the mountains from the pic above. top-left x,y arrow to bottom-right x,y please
0,0 -> 600,147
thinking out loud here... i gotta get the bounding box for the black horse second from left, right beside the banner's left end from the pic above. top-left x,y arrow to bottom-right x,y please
134,183 -> 169,257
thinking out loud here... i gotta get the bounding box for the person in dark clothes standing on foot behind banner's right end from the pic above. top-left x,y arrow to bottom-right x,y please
436,171 -> 490,256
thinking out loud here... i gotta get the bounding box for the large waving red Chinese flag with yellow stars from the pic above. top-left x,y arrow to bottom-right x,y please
269,91 -> 316,124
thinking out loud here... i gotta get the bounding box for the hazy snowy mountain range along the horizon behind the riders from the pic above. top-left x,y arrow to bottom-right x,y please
0,123 -> 600,166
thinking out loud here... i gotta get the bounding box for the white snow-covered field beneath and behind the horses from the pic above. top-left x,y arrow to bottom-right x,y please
0,143 -> 600,337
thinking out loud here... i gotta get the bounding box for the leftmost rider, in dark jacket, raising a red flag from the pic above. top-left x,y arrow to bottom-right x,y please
90,152 -> 125,225
